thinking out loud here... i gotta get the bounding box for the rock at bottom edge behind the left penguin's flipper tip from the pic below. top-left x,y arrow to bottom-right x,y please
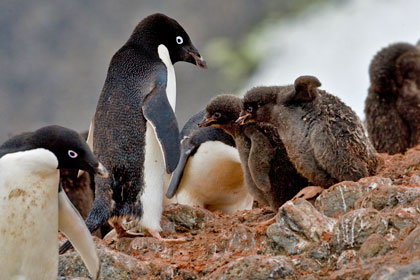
58,238 -> 149,279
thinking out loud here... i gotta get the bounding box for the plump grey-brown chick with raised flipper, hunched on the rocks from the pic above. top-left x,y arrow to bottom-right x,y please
240,76 -> 378,187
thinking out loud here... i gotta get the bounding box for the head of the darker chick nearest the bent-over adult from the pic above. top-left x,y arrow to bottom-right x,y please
200,94 -> 241,134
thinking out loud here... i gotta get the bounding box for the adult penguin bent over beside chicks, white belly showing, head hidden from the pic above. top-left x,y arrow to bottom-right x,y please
166,110 -> 253,214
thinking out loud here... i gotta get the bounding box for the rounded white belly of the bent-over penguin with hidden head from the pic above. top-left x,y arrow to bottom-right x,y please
176,141 -> 253,213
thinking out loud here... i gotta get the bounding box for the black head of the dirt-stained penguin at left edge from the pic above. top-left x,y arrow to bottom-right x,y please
26,125 -> 108,177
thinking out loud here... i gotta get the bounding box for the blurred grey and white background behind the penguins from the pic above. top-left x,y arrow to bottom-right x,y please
0,0 -> 420,142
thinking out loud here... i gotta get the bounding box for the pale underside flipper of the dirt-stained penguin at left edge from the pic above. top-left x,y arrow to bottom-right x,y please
58,188 -> 101,279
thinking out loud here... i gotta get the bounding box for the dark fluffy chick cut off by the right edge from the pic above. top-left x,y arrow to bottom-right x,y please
365,43 -> 420,154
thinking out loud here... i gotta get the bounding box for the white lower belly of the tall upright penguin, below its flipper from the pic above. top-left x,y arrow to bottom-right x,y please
139,121 -> 165,231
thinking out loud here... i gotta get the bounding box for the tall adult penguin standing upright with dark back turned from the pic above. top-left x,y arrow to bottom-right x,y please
60,14 -> 206,253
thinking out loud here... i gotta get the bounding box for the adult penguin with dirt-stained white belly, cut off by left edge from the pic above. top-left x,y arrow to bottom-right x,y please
0,126 -> 107,279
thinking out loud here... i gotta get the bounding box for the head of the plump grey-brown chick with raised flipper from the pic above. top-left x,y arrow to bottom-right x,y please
237,87 -> 279,125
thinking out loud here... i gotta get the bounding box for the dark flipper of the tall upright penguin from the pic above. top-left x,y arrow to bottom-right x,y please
142,85 -> 181,173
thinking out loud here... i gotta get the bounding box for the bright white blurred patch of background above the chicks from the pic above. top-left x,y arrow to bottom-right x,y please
246,0 -> 420,119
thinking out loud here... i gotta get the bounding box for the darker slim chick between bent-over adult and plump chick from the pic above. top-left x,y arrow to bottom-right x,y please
202,94 -> 308,212
